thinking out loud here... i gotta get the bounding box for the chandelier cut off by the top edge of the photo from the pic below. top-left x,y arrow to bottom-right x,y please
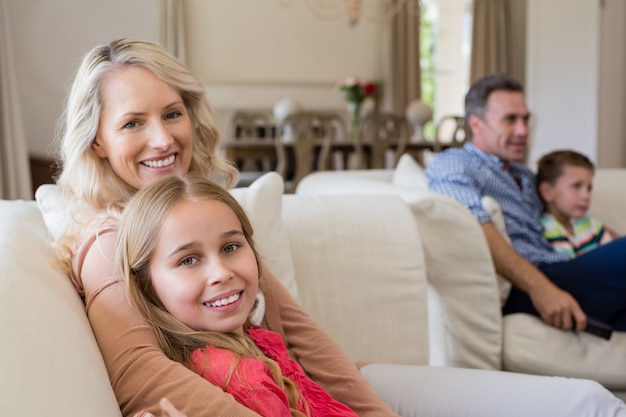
279,0 -> 420,26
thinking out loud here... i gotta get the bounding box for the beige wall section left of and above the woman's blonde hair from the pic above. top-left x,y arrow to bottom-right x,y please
9,0 -> 159,157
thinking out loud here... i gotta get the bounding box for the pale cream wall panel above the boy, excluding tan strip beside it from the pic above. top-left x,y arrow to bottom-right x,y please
526,0 -> 600,166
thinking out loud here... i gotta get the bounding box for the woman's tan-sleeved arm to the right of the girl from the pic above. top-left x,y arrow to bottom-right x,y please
263,266 -> 396,417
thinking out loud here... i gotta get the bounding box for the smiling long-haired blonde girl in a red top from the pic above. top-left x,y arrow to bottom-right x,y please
117,176 -> 357,416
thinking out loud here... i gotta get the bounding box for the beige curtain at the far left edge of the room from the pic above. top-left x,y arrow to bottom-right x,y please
0,0 -> 33,200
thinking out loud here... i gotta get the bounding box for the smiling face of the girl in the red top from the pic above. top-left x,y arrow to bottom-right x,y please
150,200 -> 259,335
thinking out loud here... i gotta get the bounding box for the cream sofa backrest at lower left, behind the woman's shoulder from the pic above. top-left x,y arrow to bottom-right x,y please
0,200 -> 121,417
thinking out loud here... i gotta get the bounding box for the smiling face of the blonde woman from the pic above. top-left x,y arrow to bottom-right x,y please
91,66 -> 193,189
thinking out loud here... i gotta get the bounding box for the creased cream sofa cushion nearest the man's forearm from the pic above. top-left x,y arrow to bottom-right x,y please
410,192 -> 502,369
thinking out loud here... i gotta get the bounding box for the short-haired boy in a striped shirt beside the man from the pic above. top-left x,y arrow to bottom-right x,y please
537,150 -> 617,258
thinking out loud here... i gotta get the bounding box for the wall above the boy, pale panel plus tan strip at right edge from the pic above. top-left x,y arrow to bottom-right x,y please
526,0 -> 626,168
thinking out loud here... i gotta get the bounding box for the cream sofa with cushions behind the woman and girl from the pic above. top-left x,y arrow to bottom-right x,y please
0,161 -> 620,417
